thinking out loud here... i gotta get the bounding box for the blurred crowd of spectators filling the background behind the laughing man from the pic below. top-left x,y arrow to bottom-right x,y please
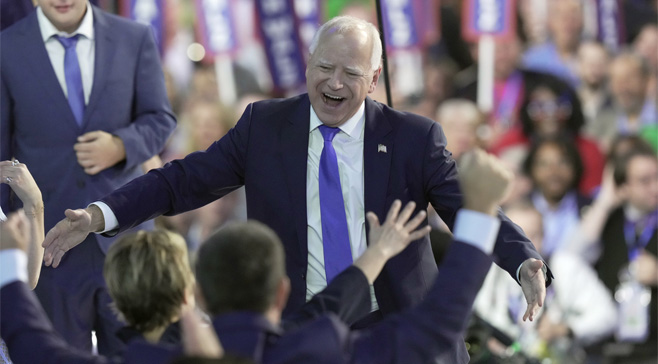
0,0 -> 658,363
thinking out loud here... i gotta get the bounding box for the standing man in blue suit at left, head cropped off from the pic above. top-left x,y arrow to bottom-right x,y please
0,0 -> 176,353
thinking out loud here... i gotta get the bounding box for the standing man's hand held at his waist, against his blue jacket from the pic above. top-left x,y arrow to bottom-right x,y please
73,130 -> 126,175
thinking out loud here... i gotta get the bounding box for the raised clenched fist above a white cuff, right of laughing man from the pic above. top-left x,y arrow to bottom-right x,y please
459,149 -> 514,216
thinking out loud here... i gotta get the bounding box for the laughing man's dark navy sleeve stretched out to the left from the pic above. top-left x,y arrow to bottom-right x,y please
101,105 -> 253,235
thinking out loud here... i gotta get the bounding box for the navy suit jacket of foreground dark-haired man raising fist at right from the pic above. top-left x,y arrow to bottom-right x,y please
208,241 -> 491,364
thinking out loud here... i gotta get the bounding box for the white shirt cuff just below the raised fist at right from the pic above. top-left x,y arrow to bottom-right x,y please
454,209 -> 500,254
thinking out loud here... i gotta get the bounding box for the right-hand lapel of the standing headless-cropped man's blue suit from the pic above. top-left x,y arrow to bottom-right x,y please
82,6 -> 114,127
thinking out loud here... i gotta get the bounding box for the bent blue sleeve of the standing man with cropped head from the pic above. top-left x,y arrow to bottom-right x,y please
112,28 -> 176,169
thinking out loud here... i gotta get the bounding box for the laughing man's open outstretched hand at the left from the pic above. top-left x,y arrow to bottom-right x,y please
41,205 -> 105,268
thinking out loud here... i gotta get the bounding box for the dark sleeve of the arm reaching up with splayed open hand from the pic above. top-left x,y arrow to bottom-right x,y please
282,266 -> 370,331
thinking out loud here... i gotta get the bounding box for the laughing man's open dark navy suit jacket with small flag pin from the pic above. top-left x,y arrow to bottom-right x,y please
102,94 -> 541,314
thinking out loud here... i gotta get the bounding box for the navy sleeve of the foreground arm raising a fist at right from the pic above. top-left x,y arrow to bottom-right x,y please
345,241 -> 491,363
